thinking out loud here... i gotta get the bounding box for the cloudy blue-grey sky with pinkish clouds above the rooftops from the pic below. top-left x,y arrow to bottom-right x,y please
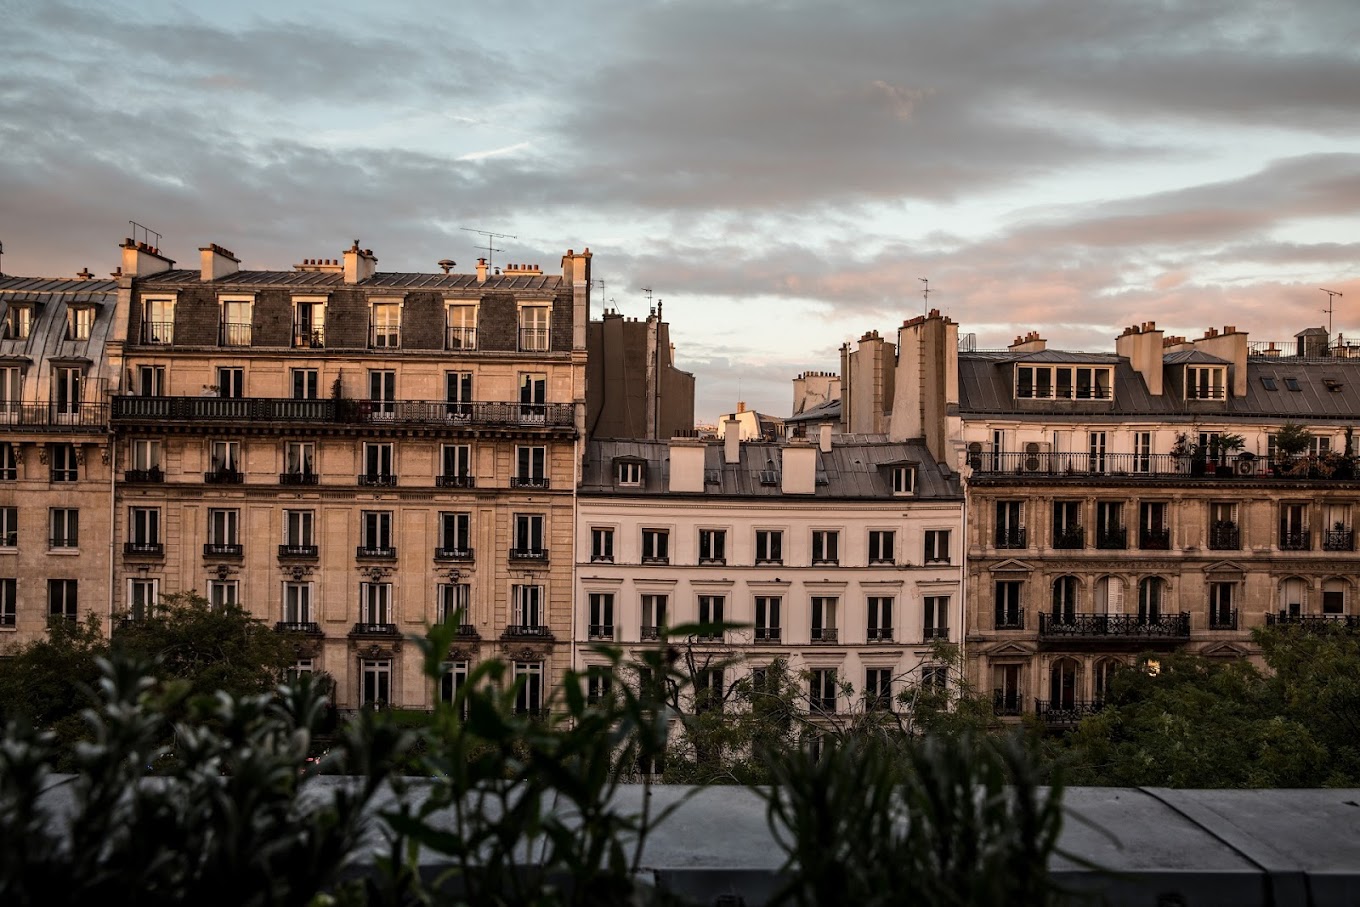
0,0 -> 1360,422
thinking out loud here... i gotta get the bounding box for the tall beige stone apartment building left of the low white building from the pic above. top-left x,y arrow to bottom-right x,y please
103,241 -> 590,710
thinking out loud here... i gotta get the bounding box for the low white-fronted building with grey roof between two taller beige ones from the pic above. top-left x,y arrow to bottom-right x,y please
574,420 -> 963,714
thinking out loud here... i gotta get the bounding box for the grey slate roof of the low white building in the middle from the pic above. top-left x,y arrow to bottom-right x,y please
579,439 -> 963,500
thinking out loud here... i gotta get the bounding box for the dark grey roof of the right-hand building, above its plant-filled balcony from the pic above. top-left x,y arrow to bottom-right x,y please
959,352 -> 1360,423
